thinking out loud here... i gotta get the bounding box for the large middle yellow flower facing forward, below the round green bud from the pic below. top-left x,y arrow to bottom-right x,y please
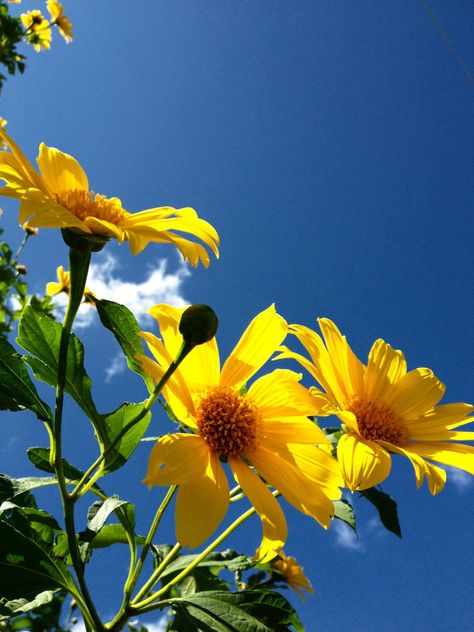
139,305 -> 342,561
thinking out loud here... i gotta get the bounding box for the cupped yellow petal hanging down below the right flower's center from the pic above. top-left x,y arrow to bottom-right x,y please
337,434 -> 392,491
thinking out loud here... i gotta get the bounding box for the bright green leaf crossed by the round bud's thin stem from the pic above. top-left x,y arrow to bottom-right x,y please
101,402 -> 151,472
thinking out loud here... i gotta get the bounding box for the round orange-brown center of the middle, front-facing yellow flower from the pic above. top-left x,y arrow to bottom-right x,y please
197,386 -> 261,461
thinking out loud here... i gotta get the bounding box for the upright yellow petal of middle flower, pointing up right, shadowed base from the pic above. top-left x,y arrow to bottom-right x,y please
220,305 -> 288,388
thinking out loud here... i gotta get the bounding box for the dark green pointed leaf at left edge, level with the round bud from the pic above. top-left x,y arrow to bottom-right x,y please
0,336 -> 53,423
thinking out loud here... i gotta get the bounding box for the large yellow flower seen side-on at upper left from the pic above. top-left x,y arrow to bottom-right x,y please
0,130 -> 219,267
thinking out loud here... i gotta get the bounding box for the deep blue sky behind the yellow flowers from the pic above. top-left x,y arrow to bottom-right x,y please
0,0 -> 474,632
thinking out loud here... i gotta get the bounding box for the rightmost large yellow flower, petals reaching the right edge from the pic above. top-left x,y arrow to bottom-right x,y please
278,318 -> 474,494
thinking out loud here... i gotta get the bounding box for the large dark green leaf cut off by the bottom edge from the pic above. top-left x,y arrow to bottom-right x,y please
168,590 -> 304,632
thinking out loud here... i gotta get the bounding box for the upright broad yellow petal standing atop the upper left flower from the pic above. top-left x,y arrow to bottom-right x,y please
36,143 -> 89,193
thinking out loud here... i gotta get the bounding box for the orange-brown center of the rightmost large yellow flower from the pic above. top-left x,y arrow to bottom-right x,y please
349,397 -> 408,445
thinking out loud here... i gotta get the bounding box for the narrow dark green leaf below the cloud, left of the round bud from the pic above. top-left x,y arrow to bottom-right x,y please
96,300 -> 154,393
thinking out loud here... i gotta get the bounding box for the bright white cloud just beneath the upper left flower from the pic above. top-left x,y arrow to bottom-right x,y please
48,253 -> 191,328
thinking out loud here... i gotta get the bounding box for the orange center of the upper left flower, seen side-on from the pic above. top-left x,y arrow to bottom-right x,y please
54,189 -> 127,225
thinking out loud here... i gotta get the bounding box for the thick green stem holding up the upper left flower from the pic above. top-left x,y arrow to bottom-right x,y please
50,248 -> 104,631
